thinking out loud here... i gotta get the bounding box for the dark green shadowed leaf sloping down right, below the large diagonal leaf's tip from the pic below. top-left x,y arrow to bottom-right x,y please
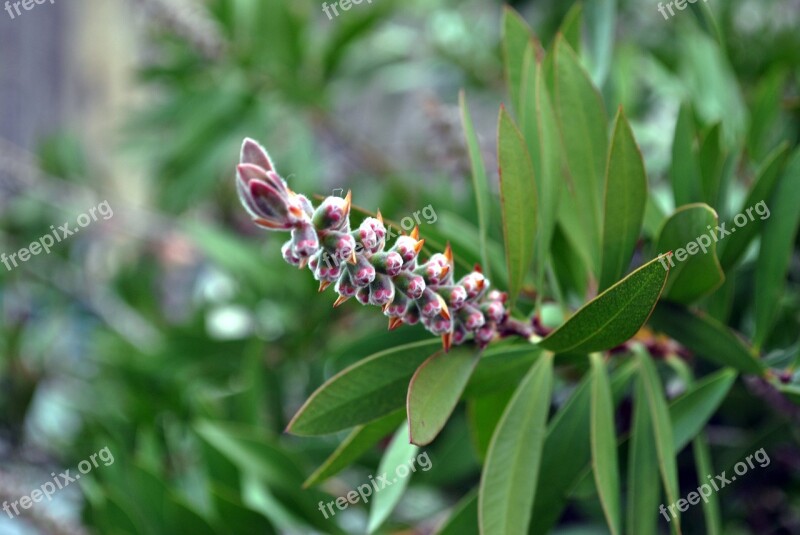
650,303 -> 763,375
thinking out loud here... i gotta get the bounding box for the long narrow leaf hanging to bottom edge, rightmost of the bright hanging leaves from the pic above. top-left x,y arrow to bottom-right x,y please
636,350 -> 680,532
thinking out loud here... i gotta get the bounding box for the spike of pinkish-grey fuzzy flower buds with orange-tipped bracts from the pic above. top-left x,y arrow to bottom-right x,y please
236,139 -> 508,350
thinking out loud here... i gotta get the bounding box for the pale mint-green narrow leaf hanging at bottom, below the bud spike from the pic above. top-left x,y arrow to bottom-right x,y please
367,423 -> 419,533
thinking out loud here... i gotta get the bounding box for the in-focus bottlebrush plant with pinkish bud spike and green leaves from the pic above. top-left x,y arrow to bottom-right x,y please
236,7 -> 800,535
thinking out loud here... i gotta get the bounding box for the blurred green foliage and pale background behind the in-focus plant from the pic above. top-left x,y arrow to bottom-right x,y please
0,0 -> 800,534
